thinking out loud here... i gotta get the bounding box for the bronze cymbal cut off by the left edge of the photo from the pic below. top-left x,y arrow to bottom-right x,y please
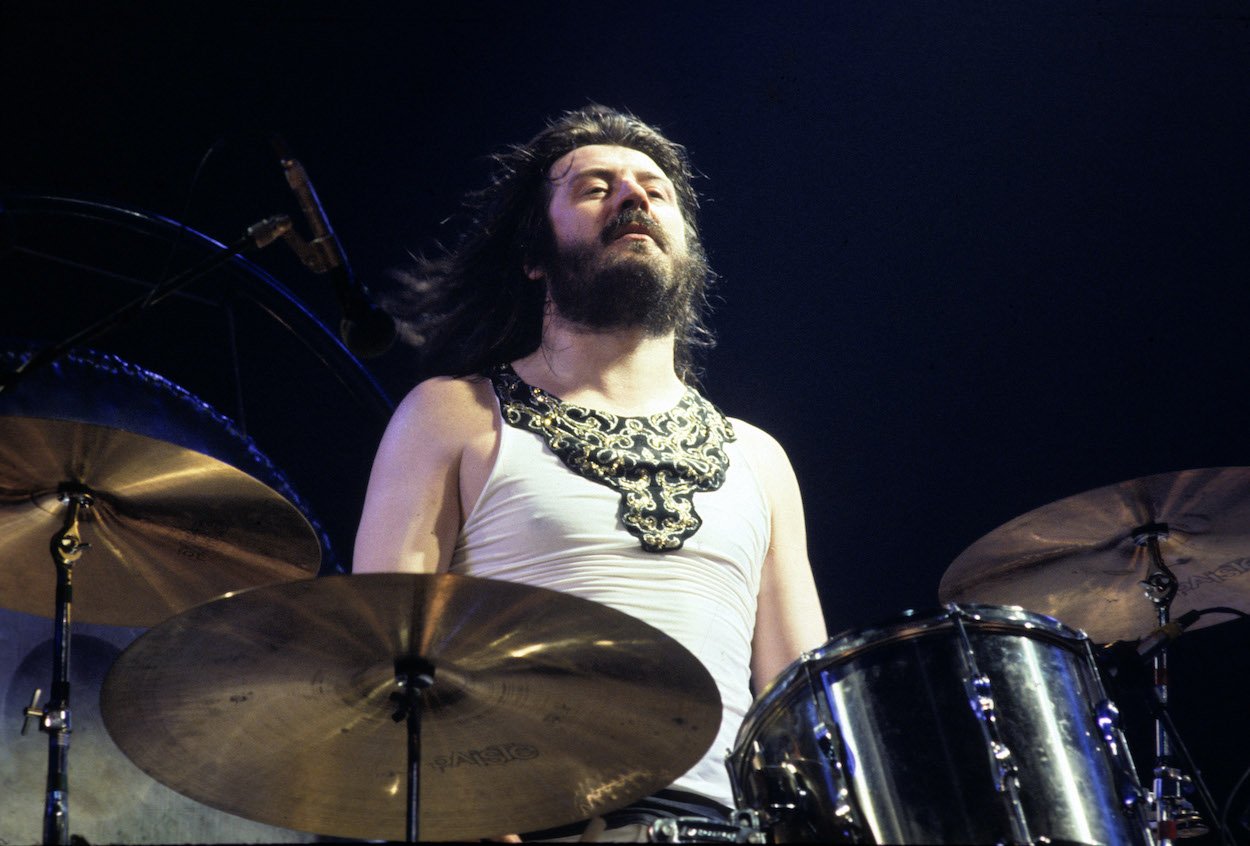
0,416 -> 321,626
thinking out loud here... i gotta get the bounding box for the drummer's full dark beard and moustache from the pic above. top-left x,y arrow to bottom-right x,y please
548,212 -> 708,336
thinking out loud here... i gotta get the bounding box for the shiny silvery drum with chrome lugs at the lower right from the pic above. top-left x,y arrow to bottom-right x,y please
729,605 -> 1151,846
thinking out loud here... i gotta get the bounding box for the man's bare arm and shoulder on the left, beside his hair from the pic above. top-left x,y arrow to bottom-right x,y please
351,379 -> 494,572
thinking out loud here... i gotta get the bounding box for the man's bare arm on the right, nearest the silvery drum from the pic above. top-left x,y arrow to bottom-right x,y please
735,421 -> 829,691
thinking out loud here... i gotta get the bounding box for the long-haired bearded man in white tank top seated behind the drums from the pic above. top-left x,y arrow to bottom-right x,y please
354,106 -> 826,840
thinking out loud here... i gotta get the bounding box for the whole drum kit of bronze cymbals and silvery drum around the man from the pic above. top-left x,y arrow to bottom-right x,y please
0,206 -> 1250,846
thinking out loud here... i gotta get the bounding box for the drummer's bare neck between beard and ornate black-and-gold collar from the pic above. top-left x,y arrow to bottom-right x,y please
513,315 -> 685,416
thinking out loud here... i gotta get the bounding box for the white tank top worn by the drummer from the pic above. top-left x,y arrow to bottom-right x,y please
450,379 -> 770,807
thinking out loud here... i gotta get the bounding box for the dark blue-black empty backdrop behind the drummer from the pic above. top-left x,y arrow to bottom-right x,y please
0,0 -> 1250,836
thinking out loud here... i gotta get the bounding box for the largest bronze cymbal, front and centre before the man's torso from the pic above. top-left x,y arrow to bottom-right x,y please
101,574 -> 720,840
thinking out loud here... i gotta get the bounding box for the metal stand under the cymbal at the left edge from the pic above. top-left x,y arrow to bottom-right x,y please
23,482 -> 95,846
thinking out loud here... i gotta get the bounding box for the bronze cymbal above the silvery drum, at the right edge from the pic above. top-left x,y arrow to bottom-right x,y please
939,467 -> 1250,642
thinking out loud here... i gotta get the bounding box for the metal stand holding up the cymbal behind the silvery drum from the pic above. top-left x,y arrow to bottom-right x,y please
1133,522 -> 1208,846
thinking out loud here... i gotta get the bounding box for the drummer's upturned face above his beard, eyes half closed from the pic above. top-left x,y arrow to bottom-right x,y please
548,144 -> 686,264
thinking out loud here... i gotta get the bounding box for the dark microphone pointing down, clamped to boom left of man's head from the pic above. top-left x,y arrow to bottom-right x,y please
274,144 -> 396,359
